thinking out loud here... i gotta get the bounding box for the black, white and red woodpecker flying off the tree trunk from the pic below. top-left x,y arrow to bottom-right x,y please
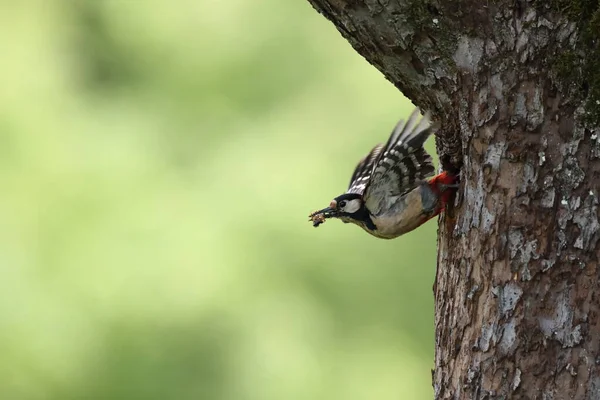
309,109 -> 458,239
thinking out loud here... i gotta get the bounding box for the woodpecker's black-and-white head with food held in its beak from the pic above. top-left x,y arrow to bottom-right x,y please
308,193 -> 374,229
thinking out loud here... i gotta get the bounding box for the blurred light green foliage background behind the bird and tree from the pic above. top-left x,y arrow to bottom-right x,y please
0,0 -> 436,400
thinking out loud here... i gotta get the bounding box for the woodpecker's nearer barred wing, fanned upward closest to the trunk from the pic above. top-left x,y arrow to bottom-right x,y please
364,109 -> 435,215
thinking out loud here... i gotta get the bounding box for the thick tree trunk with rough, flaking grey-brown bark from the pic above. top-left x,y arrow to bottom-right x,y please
309,0 -> 600,400
